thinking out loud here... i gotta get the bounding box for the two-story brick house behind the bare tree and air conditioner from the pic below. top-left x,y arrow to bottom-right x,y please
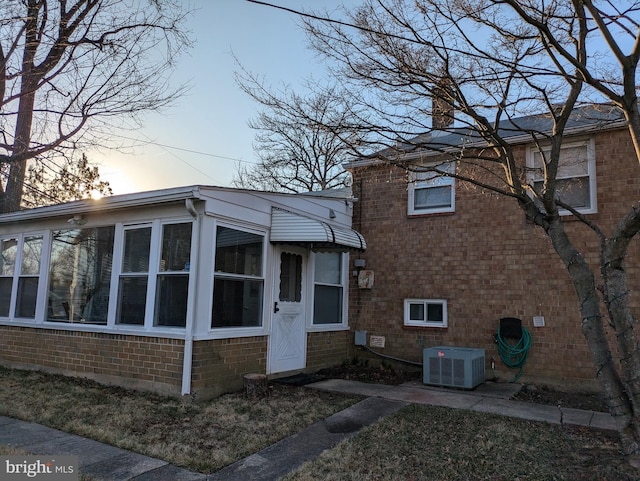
346,107 -> 640,387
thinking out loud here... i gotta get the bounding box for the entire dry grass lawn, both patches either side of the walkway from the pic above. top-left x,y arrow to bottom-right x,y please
0,368 -> 640,481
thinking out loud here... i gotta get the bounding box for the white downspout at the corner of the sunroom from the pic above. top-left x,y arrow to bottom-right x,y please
182,199 -> 200,396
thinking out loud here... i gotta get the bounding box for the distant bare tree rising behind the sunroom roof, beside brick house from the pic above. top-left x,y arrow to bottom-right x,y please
232,66 -> 359,192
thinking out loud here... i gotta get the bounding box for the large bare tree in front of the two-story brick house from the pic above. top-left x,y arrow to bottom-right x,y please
250,0 -> 640,455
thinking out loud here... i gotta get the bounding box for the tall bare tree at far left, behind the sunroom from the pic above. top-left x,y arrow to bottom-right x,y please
0,0 -> 189,212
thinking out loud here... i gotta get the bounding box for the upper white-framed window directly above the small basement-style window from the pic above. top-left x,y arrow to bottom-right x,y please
408,162 -> 456,215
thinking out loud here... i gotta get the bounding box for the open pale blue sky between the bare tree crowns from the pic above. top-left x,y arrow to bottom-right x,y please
94,0 -> 344,194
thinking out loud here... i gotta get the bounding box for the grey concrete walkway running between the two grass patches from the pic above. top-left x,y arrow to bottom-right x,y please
0,379 -> 616,481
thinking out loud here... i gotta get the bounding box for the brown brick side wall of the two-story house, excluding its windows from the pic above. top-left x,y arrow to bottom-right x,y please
349,131 -> 640,390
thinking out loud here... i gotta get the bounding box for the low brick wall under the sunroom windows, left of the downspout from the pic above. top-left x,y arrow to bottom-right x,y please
0,326 -> 184,395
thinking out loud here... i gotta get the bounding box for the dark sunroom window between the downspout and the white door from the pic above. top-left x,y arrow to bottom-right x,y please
211,226 -> 264,328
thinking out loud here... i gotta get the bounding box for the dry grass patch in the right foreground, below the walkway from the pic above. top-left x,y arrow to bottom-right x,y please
283,405 -> 640,481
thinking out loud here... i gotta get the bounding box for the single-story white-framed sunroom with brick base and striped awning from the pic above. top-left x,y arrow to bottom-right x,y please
0,186 -> 366,399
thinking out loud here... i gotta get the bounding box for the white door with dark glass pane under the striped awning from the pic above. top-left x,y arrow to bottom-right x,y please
269,246 -> 307,373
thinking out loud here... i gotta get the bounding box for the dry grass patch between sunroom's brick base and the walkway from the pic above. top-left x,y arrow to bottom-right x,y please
0,367 -> 360,473
